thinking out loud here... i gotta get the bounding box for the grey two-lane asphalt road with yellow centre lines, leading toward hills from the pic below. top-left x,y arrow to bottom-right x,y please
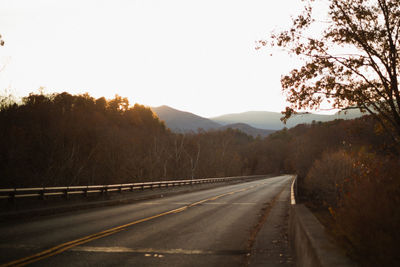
0,176 -> 293,267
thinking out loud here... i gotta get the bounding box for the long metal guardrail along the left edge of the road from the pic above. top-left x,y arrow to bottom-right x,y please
0,175 -> 265,200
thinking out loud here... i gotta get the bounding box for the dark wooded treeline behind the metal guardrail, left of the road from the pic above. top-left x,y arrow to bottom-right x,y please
0,93 -> 266,188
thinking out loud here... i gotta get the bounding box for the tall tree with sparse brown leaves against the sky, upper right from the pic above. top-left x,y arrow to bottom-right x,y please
260,0 -> 400,142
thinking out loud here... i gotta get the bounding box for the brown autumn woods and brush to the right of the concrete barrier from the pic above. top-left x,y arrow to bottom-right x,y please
254,116 -> 400,266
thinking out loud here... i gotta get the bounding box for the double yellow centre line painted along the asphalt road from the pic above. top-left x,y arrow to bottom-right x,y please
0,185 -> 257,267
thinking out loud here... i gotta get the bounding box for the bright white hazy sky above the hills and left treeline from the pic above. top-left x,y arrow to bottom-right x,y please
0,0 -> 301,117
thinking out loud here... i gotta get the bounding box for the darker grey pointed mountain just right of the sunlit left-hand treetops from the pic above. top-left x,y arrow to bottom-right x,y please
151,106 -> 221,132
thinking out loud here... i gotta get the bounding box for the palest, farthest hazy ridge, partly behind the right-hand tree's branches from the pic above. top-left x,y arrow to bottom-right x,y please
211,110 -> 362,130
